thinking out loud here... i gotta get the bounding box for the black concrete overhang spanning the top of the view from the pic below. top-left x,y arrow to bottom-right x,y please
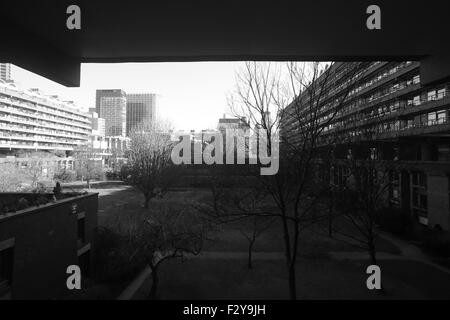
0,0 -> 450,86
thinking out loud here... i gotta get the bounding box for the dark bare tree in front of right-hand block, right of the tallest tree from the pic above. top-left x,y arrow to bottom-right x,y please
316,98 -> 414,264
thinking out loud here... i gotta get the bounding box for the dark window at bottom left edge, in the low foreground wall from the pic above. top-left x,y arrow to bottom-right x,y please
0,239 -> 14,298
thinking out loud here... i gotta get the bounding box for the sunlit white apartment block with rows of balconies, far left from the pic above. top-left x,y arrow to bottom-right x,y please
0,80 -> 91,155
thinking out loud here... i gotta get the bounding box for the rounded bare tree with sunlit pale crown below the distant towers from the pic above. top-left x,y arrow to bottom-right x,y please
121,123 -> 177,208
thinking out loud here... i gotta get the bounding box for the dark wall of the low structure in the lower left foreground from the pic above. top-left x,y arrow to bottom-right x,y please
0,193 -> 98,299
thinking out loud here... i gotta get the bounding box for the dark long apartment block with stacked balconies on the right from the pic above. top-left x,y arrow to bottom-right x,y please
281,61 -> 450,230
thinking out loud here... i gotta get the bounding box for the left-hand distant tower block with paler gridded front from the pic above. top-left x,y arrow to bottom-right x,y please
95,89 -> 127,137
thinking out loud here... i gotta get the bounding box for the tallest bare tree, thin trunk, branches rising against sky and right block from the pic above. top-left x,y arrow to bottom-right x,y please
228,62 -> 361,299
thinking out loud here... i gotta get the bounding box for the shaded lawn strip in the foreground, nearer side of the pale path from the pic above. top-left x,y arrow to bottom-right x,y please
140,257 -> 432,299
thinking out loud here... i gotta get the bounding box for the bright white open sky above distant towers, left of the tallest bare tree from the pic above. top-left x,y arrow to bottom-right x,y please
11,62 -> 248,130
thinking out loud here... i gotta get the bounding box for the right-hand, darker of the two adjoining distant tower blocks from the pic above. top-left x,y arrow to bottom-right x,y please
127,93 -> 156,136
